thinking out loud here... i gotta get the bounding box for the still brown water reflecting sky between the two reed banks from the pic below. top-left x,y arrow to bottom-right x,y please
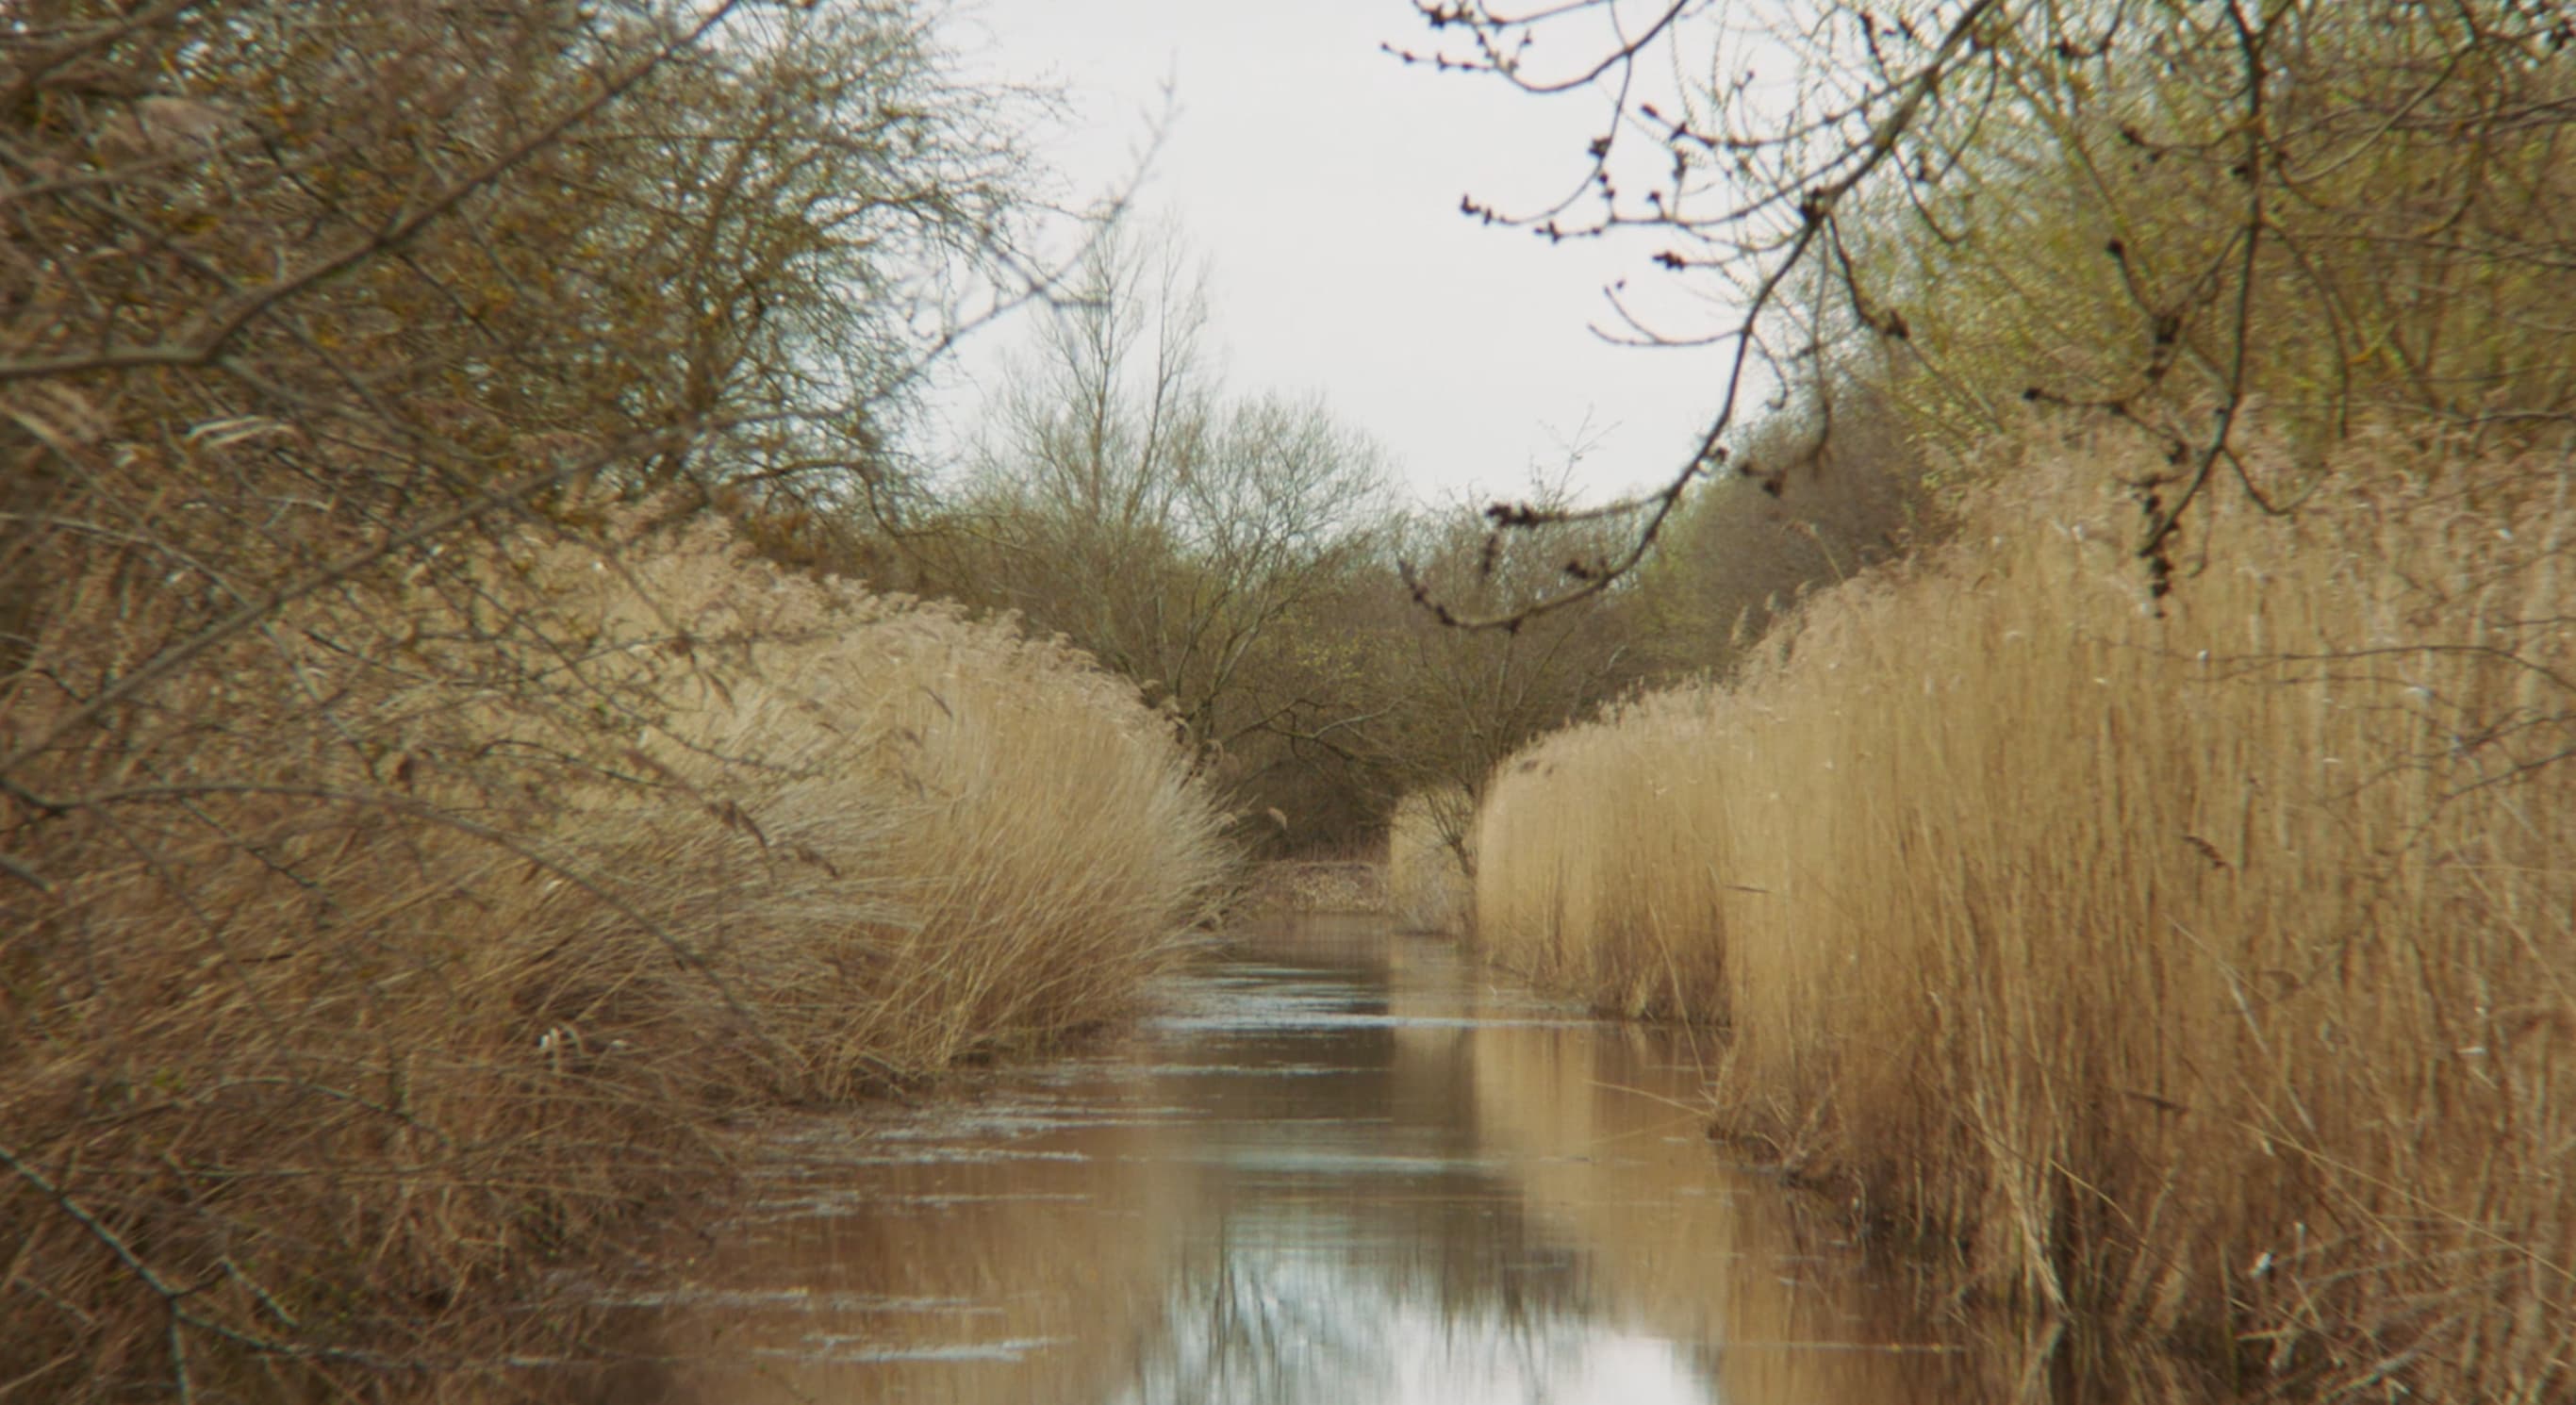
574,920 -> 1991,1405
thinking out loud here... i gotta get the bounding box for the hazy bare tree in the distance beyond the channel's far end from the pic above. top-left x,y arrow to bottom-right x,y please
943,235 -> 1394,788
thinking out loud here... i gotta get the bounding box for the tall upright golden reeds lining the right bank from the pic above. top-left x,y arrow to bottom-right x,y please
1476,441 -> 2576,1400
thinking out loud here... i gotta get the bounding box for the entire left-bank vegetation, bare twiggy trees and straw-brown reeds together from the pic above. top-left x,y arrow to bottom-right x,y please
0,0 -> 1221,1400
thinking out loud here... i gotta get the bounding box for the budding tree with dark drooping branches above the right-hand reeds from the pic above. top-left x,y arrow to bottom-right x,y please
1398,0 -> 2576,626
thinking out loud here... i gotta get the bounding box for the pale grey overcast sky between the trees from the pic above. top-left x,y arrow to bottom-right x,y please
943,0 -> 1721,498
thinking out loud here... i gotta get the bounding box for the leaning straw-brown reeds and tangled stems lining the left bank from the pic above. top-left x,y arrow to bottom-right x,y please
0,513 -> 1221,1400
